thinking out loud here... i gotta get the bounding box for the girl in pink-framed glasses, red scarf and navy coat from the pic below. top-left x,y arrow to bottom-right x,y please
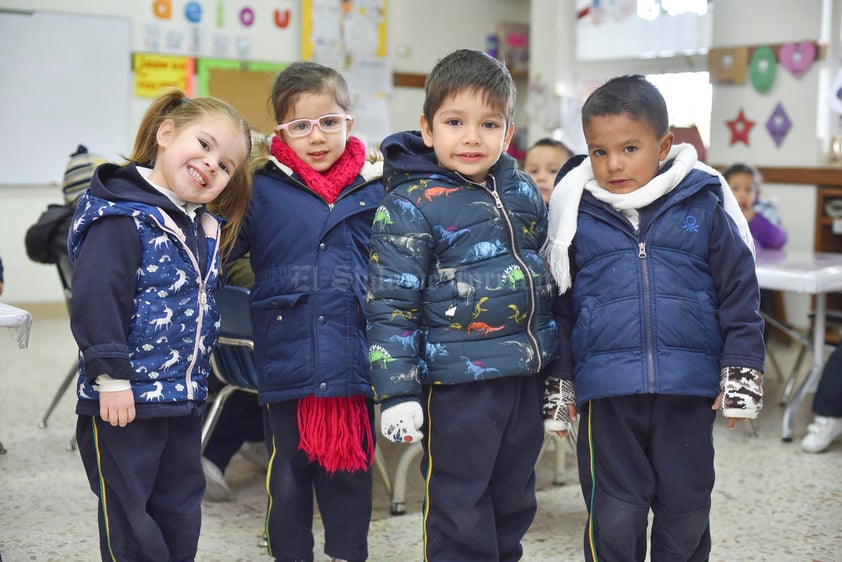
226,62 -> 384,561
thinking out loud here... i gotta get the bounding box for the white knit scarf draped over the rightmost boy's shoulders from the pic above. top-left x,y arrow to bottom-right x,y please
542,144 -> 754,293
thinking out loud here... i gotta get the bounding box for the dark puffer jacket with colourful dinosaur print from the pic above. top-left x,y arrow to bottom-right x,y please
366,132 -> 559,407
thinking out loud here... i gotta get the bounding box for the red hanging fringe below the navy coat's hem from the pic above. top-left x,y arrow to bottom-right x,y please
298,394 -> 374,475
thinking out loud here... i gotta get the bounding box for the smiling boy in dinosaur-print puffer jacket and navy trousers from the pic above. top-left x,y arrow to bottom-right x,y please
366,50 -> 558,561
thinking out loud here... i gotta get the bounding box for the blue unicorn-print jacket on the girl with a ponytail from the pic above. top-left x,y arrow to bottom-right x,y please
68,165 -> 219,418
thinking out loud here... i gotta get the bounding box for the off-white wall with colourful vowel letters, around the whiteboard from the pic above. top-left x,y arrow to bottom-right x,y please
0,0 -> 530,305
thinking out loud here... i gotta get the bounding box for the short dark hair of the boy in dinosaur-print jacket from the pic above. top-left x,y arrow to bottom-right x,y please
424,49 -> 517,127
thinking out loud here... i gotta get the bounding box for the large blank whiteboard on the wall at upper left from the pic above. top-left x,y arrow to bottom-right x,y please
0,12 -> 133,185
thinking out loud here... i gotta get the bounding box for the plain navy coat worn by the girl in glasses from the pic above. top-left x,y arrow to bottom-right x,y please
232,155 -> 384,404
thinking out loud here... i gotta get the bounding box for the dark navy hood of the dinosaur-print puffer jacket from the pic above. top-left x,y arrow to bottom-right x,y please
380,131 -> 515,192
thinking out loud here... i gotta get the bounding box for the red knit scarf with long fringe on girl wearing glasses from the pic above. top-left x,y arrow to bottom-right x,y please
272,133 -> 374,474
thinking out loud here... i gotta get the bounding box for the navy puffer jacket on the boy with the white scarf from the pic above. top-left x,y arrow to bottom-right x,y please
554,164 -> 765,406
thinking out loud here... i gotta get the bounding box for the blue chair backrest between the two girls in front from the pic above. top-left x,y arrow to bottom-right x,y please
211,285 -> 257,390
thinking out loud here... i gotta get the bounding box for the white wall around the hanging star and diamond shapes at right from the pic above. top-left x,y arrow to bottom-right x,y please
708,0 -> 842,327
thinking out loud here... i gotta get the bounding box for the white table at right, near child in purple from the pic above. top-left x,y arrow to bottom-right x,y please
755,250 -> 842,441
